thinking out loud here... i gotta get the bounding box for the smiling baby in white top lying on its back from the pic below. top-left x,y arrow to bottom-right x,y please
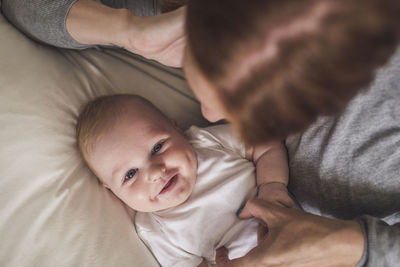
77,95 -> 293,267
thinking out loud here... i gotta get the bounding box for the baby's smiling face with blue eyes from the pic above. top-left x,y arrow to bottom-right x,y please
87,105 -> 197,212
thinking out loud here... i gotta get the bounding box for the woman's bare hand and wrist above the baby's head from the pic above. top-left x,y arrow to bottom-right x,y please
66,0 -> 186,67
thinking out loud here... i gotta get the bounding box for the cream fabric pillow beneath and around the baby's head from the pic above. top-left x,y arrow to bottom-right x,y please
0,8 -> 206,267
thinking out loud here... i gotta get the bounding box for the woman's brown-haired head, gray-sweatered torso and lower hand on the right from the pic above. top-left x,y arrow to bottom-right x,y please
184,0 -> 400,266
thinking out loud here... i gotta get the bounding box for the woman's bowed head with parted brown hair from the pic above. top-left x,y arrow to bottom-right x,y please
184,0 -> 400,144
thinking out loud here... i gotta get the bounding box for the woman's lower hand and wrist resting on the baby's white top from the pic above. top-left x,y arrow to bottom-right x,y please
216,199 -> 364,267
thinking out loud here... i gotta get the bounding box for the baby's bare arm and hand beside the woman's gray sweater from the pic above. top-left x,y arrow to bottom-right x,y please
247,142 -> 294,207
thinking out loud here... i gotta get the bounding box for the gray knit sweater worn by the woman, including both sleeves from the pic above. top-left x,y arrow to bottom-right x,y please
2,0 -> 400,267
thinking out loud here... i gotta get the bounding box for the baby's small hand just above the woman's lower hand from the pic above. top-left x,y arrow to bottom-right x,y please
257,182 -> 295,208
